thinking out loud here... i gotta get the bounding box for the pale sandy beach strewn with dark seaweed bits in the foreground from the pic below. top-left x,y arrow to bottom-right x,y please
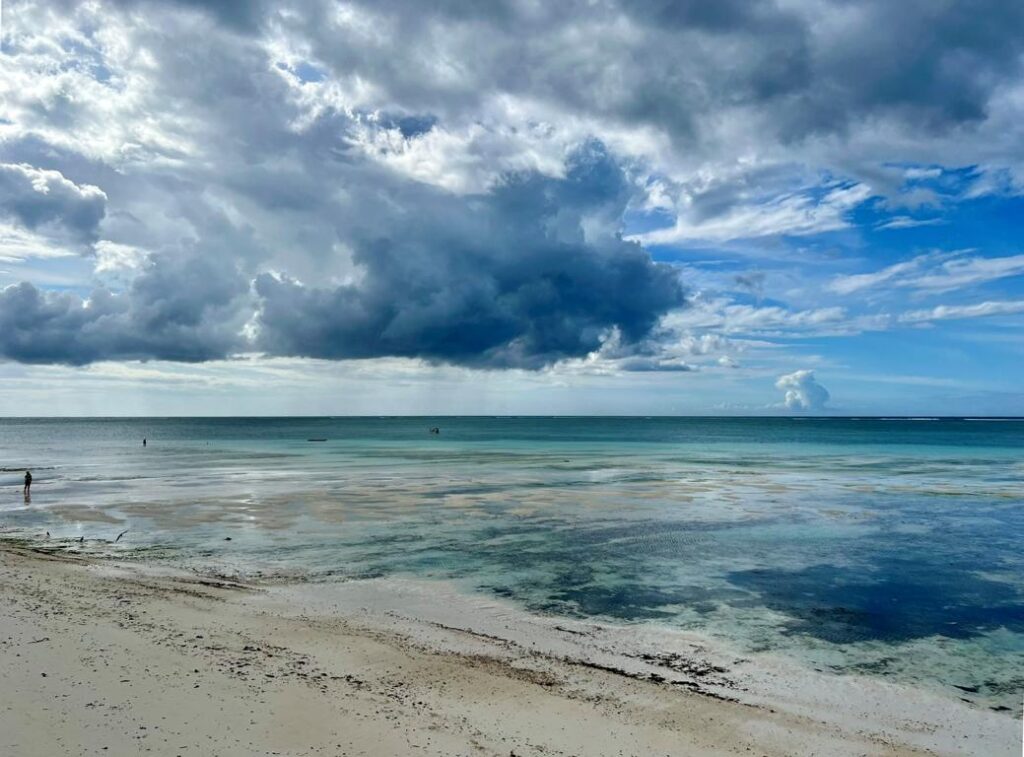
0,544 -> 1020,755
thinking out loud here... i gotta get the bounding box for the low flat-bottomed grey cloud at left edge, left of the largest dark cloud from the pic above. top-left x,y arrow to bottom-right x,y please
0,250 -> 249,365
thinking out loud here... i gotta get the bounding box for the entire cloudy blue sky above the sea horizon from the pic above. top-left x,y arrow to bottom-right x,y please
0,0 -> 1024,416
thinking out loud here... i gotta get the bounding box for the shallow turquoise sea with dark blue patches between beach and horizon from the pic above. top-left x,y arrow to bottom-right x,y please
0,418 -> 1024,713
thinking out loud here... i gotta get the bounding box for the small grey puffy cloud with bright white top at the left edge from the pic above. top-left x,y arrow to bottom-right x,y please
0,163 -> 106,243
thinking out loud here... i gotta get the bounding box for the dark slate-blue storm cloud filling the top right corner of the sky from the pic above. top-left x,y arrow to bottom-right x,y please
779,0 -> 1024,136
